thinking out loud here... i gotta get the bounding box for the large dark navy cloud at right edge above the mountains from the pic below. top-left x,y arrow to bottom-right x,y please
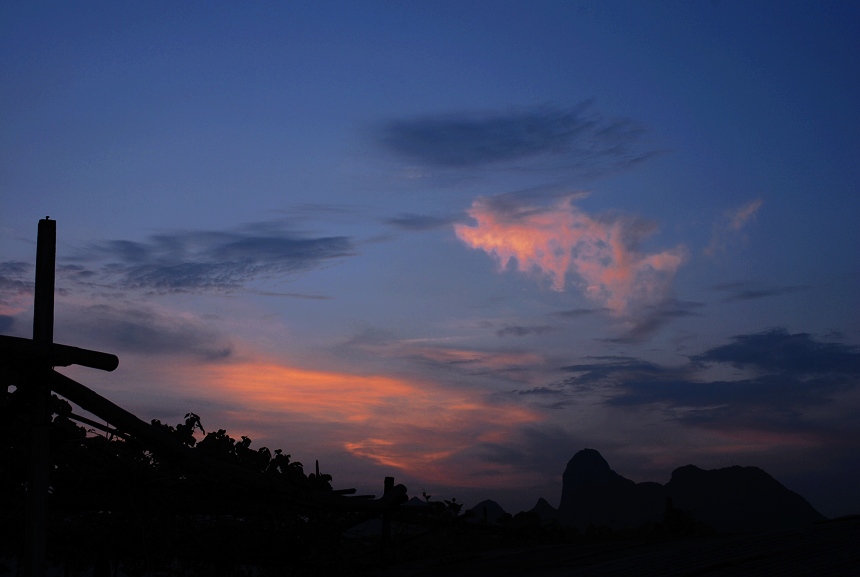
563,329 -> 860,432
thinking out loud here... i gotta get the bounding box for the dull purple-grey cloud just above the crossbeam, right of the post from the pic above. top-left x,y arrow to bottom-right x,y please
58,304 -> 232,361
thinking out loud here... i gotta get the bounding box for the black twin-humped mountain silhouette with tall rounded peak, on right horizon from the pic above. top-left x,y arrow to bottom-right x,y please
558,449 -> 824,533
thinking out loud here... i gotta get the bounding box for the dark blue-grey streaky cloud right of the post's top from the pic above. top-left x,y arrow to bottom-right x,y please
71,223 -> 355,292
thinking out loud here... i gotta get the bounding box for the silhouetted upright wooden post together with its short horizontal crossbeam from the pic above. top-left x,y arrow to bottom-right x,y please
0,217 -> 119,577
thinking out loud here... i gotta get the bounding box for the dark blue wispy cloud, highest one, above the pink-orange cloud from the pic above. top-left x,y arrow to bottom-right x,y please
376,102 -> 655,173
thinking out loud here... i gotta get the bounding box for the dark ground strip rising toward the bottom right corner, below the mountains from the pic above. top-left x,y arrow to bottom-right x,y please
362,516 -> 860,577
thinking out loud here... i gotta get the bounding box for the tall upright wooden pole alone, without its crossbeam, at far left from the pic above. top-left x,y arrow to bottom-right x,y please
26,218 -> 57,577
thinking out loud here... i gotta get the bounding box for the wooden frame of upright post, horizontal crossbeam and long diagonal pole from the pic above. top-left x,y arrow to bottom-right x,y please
0,218 -> 406,577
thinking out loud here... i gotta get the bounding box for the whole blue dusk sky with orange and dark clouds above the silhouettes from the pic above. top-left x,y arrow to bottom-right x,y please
0,0 -> 860,516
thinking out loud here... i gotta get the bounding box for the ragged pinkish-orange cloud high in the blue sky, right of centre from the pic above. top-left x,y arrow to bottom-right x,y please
455,198 -> 685,314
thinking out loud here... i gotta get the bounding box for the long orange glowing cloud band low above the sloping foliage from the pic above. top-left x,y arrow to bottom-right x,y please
193,361 -> 540,481
